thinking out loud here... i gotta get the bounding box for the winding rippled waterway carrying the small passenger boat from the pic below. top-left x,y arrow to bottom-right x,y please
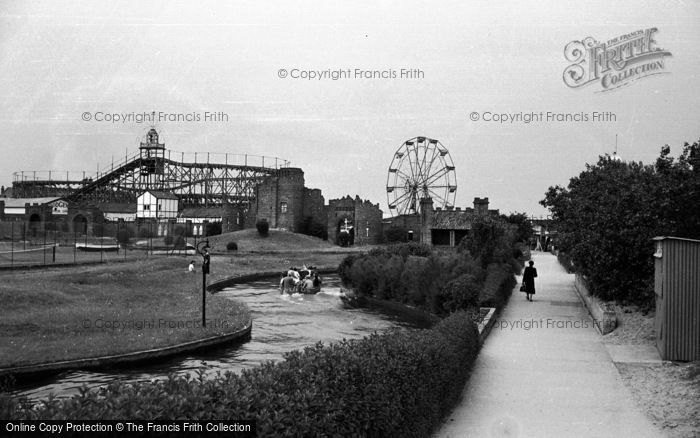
13,275 -> 423,400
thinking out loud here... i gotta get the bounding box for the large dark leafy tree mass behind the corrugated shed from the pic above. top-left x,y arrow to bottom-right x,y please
540,142 -> 700,305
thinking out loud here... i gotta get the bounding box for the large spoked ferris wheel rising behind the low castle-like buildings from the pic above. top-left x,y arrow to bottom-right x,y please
386,137 -> 457,215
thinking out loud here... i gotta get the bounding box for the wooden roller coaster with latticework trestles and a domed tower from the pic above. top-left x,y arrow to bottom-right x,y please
12,129 -> 289,209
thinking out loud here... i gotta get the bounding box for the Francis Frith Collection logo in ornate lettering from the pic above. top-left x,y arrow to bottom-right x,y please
564,27 -> 671,92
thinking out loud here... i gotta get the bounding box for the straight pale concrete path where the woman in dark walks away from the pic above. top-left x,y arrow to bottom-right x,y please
435,253 -> 662,438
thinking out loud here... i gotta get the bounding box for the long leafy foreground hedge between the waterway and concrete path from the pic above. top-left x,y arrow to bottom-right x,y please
0,312 -> 478,437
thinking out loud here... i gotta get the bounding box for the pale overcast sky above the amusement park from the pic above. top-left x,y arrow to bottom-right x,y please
0,0 -> 700,217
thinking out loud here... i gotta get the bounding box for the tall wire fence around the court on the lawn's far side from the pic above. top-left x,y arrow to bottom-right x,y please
0,221 -> 206,267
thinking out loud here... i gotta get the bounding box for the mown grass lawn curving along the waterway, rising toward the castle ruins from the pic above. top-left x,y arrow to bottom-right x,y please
0,230 -> 357,367
